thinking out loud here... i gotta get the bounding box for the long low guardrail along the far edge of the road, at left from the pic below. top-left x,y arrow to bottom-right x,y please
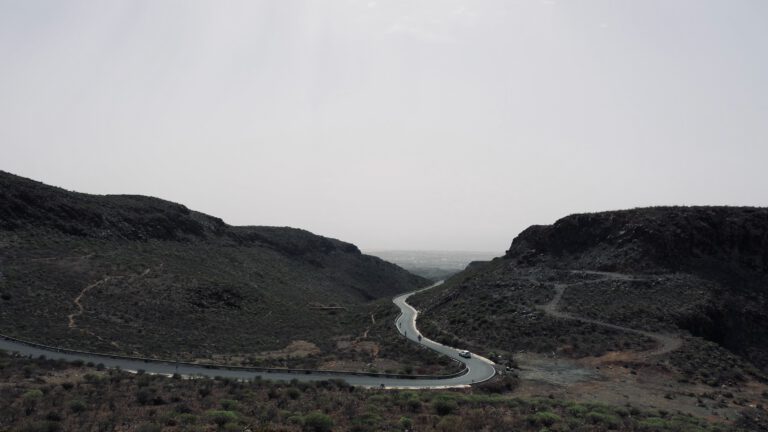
0,334 -> 469,380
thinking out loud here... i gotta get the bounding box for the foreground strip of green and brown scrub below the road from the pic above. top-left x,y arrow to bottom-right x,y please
0,354 -> 748,432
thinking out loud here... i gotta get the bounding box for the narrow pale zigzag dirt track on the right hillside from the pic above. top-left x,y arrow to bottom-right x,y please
538,271 -> 683,358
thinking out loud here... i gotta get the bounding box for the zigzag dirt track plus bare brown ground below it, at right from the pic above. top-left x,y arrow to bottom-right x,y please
514,271 -> 768,422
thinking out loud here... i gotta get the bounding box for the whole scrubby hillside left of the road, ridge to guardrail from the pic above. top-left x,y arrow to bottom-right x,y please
0,172 -> 427,361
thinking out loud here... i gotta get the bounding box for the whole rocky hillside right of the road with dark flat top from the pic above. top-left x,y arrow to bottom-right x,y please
419,207 -> 768,382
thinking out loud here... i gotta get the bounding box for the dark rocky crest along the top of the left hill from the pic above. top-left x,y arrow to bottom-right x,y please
0,171 -> 360,255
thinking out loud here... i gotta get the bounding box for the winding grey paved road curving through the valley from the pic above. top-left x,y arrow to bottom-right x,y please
0,282 -> 495,388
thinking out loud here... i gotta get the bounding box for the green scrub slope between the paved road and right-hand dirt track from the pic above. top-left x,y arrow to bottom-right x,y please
412,261 -> 653,358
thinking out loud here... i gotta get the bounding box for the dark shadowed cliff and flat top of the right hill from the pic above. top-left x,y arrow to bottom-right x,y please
504,207 -> 768,368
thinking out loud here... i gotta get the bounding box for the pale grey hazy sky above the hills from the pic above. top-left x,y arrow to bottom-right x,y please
0,0 -> 768,253
